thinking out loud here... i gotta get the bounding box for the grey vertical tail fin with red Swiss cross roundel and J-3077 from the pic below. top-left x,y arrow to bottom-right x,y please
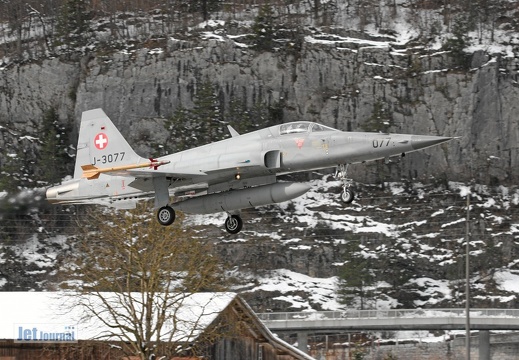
74,109 -> 146,179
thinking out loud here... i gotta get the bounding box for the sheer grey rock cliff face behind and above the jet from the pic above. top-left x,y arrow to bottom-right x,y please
0,29 -> 519,183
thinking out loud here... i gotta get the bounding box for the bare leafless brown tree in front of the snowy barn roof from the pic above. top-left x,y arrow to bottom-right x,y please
60,206 -> 231,359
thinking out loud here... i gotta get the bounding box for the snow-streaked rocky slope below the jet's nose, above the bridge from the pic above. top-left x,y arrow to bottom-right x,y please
186,176 -> 519,311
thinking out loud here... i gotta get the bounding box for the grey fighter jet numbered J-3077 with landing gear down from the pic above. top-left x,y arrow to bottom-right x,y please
46,109 -> 453,234
